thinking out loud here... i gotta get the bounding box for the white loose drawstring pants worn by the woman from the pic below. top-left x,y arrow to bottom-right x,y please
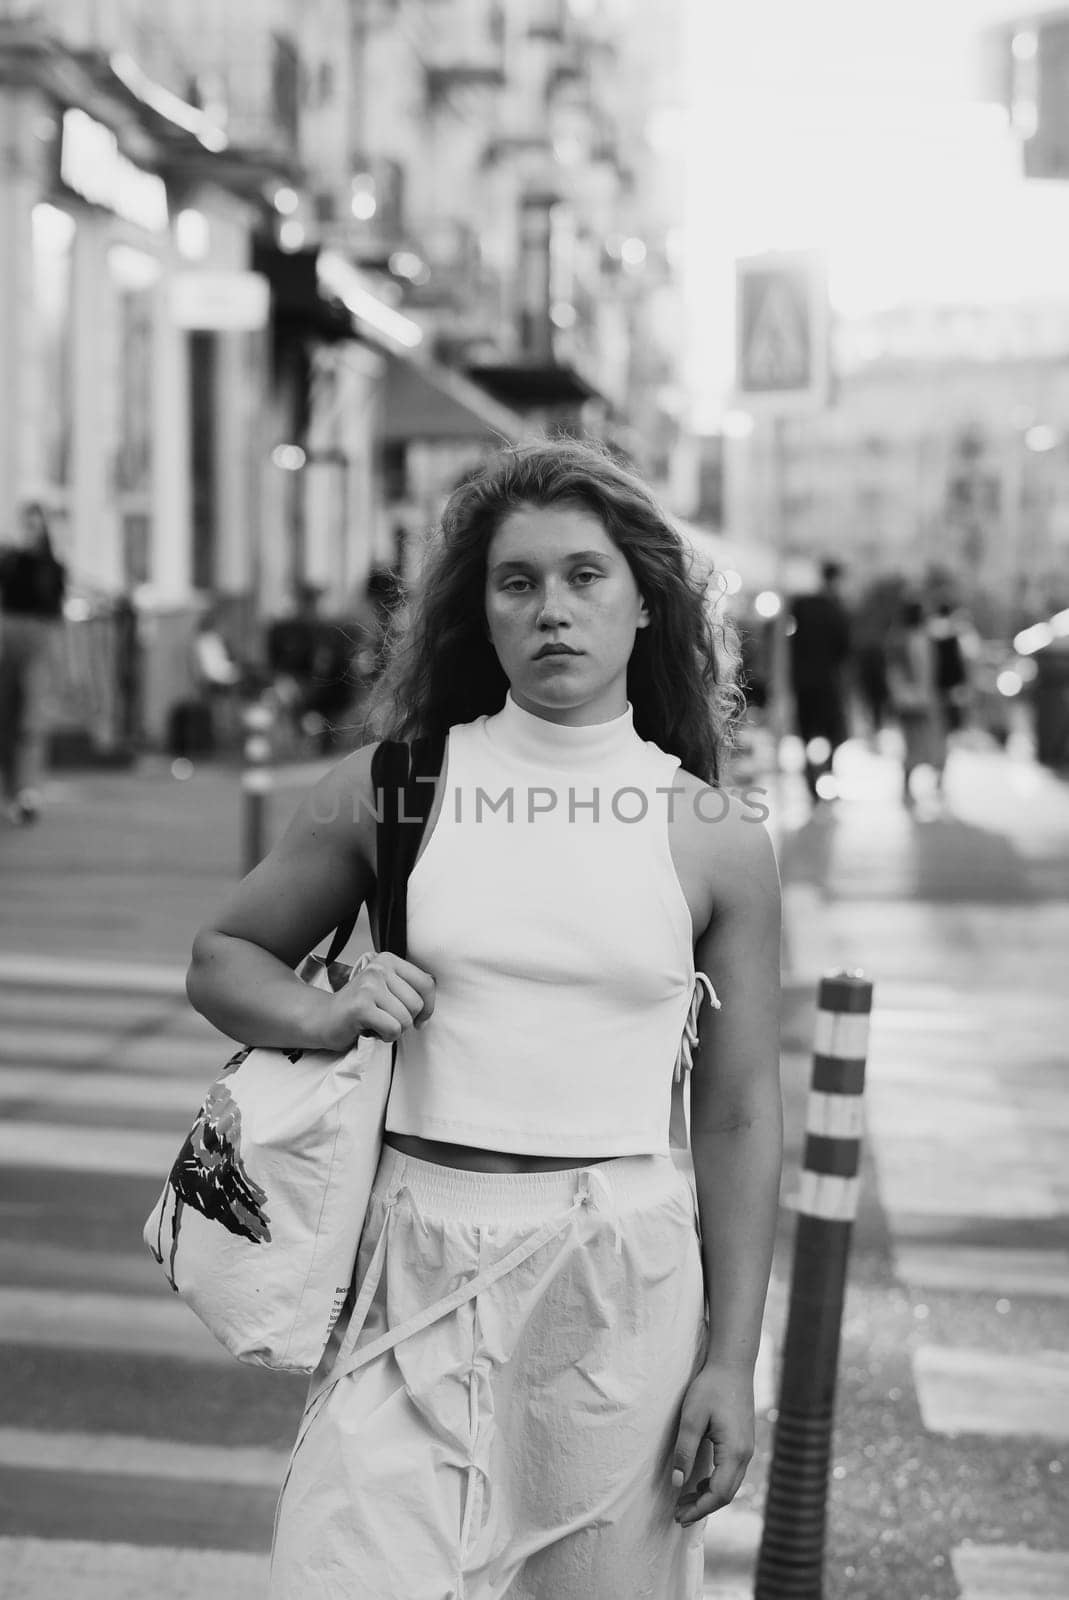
270,1147 -> 706,1600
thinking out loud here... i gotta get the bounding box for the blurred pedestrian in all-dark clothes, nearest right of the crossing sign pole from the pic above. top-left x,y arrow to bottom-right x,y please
789,562 -> 850,800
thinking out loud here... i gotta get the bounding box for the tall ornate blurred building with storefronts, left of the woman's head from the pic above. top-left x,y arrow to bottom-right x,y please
0,0 -> 682,748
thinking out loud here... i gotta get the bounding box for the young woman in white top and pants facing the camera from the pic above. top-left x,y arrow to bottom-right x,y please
189,443 -> 781,1600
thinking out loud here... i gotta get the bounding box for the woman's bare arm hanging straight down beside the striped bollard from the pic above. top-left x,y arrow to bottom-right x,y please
675,811 -> 783,1523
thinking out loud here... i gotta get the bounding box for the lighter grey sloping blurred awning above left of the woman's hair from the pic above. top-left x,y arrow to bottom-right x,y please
379,354 -> 523,445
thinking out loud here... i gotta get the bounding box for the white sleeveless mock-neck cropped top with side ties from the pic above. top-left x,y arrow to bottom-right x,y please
386,696 -> 695,1157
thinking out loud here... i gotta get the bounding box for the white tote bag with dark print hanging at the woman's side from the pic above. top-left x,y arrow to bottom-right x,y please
144,955 -> 392,1373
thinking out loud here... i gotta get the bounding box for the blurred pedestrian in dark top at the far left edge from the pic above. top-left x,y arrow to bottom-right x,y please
0,501 -> 67,824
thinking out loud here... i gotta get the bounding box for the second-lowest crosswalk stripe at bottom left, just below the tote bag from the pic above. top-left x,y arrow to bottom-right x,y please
0,1427 -> 290,1491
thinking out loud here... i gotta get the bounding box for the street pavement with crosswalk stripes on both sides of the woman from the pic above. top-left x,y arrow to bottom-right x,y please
0,732 -> 1069,1600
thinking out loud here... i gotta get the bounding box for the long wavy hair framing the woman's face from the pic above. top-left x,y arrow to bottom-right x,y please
366,440 -> 743,784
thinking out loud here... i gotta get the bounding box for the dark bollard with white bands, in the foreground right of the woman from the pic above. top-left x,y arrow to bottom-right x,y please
754,973 -> 872,1600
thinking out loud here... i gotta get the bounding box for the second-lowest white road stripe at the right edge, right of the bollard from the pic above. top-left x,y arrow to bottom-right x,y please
912,1344 -> 1069,1438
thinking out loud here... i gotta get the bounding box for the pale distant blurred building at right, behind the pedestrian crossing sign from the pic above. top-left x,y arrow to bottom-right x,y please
725,302 -> 1069,632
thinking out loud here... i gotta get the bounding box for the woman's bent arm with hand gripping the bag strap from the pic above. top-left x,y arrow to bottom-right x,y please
186,746 -> 434,1050
